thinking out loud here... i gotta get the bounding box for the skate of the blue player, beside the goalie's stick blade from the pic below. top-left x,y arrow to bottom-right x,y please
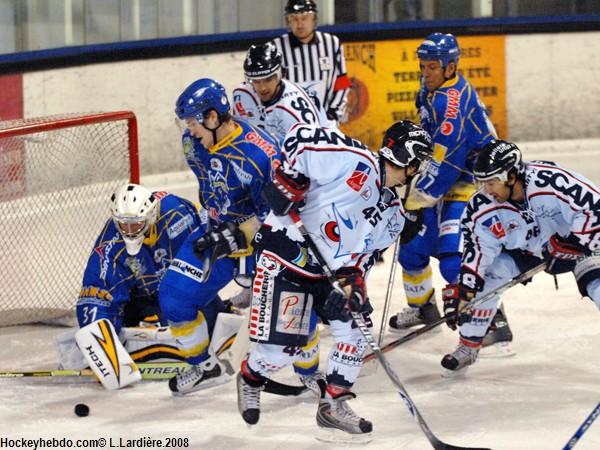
169,356 -> 231,396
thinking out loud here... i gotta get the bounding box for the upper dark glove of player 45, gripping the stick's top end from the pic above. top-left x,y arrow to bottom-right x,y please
263,161 -> 310,216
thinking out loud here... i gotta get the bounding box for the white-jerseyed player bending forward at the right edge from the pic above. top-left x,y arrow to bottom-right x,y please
442,140 -> 600,371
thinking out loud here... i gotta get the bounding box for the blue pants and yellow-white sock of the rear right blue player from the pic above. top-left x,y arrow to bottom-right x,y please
398,201 -> 466,306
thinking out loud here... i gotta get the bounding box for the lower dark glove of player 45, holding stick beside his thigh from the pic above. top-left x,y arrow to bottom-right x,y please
323,267 -> 373,322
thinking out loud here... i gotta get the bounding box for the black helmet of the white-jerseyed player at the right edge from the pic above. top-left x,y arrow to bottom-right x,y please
473,140 -> 525,181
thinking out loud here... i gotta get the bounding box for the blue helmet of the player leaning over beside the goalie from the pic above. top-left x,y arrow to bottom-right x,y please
175,78 -> 229,122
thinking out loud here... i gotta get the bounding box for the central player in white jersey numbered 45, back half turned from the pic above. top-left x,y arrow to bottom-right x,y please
238,121 -> 431,434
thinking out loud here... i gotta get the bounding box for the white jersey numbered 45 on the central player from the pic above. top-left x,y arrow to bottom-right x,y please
265,124 -> 405,270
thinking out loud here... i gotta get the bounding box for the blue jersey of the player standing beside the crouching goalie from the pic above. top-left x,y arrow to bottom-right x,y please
182,120 -> 279,227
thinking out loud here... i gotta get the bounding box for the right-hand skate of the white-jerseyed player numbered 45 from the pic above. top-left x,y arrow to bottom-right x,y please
317,391 -> 373,444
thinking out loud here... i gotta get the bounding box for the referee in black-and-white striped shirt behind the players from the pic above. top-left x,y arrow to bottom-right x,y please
273,0 -> 350,123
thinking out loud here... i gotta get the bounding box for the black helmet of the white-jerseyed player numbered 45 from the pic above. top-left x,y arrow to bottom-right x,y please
379,120 -> 433,168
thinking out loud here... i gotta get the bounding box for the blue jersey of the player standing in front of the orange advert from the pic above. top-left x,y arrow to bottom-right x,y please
416,74 -> 496,201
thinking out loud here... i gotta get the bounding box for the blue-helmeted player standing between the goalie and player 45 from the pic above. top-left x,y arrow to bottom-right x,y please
159,78 -> 279,395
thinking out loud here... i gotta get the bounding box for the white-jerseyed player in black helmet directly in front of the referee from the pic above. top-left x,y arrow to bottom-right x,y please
233,42 -> 329,142
